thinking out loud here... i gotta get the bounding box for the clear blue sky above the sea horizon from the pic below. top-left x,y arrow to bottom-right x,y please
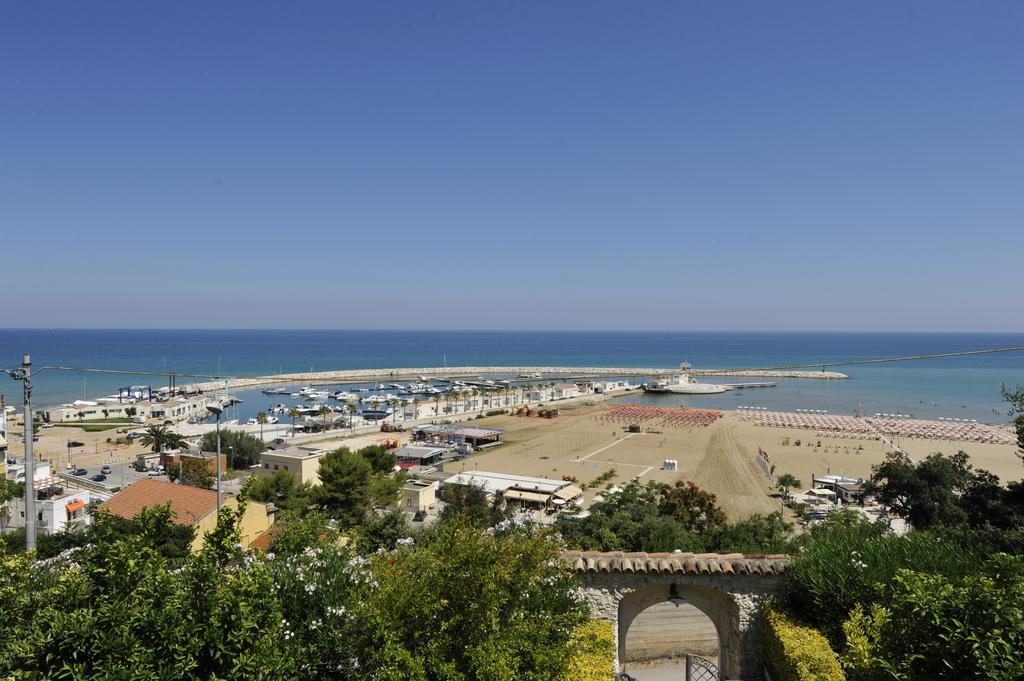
0,0 -> 1024,331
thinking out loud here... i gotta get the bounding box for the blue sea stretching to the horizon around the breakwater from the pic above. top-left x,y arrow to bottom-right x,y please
0,330 -> 1024,422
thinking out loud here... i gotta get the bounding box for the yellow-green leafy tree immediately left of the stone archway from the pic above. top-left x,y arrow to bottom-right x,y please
350,523 -> 587,681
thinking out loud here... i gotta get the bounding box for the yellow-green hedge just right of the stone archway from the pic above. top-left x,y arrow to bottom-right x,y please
764,602 -> 846,681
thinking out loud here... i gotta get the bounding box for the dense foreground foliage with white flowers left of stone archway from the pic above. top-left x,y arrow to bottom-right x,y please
0,499 -> 593,681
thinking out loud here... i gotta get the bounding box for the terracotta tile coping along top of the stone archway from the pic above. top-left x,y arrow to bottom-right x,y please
562,551 -> 790,574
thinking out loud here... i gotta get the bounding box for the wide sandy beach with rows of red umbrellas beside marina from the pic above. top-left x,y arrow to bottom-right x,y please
445,406 -> 1024,518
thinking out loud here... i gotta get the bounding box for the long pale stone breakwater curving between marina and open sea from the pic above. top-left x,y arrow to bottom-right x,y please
189,367 -> 849,391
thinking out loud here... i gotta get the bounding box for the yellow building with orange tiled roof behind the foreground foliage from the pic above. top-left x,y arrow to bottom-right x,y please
101,478 -> 274,551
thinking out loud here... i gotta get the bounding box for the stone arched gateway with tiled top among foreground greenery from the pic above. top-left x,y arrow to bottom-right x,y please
564,551 -> 788,681
